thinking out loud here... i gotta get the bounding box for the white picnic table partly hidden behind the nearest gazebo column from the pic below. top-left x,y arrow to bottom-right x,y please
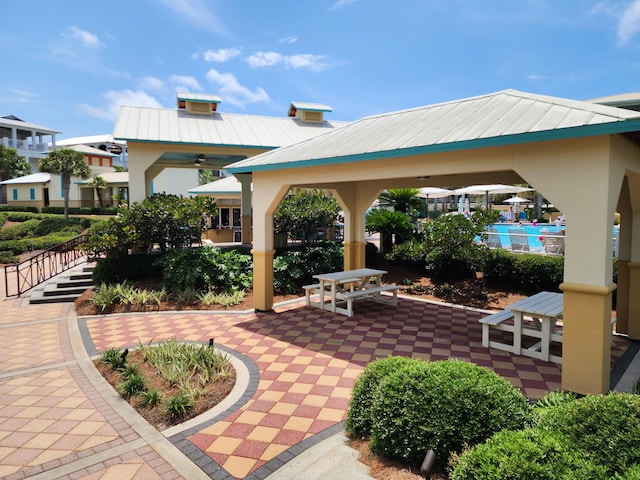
480,291 -> 563,363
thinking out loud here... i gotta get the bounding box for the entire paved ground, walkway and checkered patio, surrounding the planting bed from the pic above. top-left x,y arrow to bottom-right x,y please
0,268 -> 637,480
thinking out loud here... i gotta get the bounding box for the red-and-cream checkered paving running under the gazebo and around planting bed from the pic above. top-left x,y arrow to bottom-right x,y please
87,298 -> 626,478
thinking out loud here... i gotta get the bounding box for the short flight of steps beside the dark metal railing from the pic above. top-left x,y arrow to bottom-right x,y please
29,263 -> 94,303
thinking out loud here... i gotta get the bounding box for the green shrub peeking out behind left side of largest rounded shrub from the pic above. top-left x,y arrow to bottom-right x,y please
345,356 -> 414,437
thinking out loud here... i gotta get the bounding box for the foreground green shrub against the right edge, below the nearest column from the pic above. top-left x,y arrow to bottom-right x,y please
539,393 -> 640,475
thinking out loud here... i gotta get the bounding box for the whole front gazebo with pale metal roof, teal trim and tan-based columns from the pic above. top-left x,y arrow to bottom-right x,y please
227,90 -> 640,394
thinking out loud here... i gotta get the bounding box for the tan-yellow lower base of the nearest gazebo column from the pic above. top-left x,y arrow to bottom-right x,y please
560,283 -> 616,395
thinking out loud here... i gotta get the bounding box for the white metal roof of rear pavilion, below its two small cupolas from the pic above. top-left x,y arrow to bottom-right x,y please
113,107 -> 348,148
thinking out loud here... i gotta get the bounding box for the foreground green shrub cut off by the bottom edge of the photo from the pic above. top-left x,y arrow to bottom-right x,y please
450,428 -> 607,480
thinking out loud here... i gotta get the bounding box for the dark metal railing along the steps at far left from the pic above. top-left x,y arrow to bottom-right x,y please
4,235 -> 87,297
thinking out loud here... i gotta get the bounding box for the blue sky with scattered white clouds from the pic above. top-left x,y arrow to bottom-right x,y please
0,0 -> 640,139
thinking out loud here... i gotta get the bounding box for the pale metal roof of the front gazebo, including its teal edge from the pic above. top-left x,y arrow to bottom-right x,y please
226,90 -> 640,173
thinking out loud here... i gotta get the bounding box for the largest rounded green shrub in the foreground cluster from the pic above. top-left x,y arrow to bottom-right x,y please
370,360 -> 533,470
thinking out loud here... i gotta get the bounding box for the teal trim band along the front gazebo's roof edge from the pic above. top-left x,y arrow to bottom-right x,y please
225,119 -> 640,173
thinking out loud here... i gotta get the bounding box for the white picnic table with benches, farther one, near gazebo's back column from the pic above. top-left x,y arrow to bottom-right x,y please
304,268 -> 398,317
